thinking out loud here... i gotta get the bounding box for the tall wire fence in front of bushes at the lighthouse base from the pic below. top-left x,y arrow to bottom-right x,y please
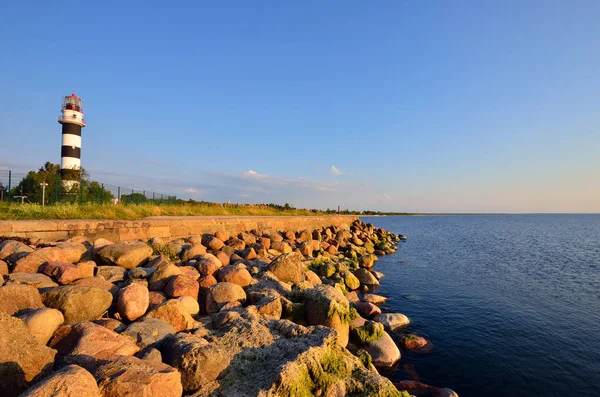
0,170 -> 177,204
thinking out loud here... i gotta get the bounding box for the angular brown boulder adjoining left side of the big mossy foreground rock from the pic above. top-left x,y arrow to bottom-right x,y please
161,334 -> 231,393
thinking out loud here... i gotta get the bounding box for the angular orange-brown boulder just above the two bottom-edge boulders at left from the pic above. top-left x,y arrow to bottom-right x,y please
49,321 -> 140,362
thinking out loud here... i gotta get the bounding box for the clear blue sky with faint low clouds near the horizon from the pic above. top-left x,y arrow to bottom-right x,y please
0,0 -> 600,212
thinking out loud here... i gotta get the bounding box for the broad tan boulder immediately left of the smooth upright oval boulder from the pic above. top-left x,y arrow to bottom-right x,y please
42,285 -> 113,324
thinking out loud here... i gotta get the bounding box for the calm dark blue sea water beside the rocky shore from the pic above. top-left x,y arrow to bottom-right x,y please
361,215 -> 600,397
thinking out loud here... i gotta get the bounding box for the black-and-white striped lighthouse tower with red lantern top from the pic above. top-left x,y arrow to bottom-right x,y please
58,94 -> 85,188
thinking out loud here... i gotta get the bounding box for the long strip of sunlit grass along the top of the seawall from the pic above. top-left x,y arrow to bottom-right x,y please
0,202 -> 326,220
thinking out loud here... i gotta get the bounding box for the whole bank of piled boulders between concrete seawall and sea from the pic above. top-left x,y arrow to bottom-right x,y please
0,221 -> 456,397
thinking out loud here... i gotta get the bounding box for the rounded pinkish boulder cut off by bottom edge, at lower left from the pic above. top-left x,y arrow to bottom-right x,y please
20,365 -> 101,397
